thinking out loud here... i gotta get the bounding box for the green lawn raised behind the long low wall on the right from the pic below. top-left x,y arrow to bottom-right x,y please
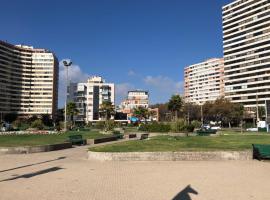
90,134 -> 270,152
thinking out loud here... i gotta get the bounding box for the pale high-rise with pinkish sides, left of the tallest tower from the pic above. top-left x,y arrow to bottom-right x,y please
184,58 -> 224,105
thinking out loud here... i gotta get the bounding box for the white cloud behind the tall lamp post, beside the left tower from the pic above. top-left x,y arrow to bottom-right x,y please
58,60 -> 89,107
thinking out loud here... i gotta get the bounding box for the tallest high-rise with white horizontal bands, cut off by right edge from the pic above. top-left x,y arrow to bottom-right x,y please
223,0 -> 270,108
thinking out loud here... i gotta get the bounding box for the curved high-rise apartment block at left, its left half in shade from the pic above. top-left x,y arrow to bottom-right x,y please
0,41 -> 59,116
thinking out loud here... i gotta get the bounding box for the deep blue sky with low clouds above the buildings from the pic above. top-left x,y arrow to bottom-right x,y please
0,0 -> 233,107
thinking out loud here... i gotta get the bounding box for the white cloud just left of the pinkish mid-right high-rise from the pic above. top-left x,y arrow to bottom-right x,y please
144,76 -> 183,94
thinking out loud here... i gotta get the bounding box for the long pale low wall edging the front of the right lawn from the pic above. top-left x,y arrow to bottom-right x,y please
88,151 -> 253,161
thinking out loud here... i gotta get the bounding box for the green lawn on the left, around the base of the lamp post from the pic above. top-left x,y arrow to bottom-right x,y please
0,131 -> 104,147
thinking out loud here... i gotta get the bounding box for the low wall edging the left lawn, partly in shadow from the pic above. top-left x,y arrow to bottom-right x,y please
0,142 -> 72,154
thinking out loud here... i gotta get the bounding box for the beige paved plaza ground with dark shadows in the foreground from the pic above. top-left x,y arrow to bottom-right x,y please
0,147 -> 270,200
